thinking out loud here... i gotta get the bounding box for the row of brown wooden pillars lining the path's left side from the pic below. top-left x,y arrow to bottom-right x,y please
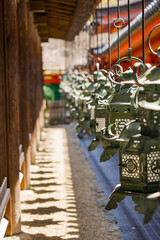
0,0 -> 44,235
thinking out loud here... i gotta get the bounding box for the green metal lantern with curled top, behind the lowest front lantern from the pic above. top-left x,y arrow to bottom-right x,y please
100,52 -> 152,162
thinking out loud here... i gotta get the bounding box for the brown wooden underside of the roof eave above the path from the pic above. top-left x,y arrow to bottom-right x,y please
29,0 -> 100,42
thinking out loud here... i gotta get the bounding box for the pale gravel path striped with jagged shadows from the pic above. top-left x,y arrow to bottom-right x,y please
4,125 -> 122,240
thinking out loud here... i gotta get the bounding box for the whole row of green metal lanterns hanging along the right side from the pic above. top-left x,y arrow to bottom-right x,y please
60,0 -> 160,223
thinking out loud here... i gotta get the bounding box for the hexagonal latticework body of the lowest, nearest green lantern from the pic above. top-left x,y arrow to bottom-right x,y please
119,140 -> 160,193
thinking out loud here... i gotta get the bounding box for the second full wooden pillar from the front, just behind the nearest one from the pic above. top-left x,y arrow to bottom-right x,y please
18,0 -> 31,189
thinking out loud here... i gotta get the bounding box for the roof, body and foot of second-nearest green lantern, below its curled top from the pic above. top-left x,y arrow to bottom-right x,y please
100,80 -> 137,162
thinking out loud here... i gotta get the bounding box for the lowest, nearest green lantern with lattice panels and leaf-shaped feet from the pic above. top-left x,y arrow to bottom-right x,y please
106,134 -> 160,217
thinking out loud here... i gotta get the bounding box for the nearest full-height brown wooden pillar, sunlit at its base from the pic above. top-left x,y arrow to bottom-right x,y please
3,0 -> 21,233
